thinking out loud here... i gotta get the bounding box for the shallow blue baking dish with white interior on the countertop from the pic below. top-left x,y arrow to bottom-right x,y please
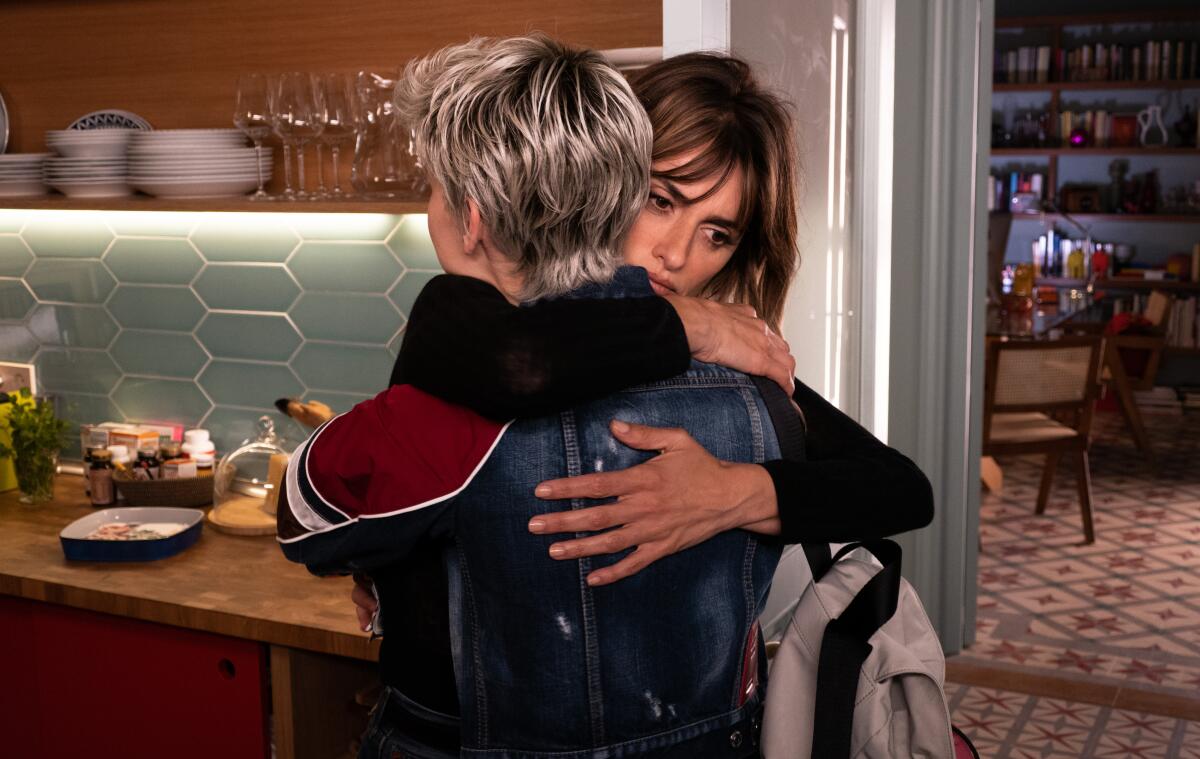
59,507 -> 204,561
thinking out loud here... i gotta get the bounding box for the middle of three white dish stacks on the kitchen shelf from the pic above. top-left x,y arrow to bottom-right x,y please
42,129 -> 137,198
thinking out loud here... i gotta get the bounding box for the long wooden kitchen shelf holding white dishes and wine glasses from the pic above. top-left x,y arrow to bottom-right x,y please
0,195 -> 426,214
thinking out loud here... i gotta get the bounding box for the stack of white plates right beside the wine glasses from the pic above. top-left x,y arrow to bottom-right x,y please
128,130 -> 271,198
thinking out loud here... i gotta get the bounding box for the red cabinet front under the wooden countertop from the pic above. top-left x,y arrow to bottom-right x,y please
0,596 -> 270,759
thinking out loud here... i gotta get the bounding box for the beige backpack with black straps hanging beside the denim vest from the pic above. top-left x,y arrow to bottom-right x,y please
762,540 -> 950,759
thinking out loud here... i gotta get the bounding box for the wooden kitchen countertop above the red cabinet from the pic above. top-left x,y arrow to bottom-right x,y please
0,474 -> 378,661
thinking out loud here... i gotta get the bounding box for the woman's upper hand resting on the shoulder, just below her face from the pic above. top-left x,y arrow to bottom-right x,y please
665,295 -> 796,396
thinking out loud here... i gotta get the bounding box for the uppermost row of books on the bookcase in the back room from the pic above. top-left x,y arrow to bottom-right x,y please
994,40 -> 1200,84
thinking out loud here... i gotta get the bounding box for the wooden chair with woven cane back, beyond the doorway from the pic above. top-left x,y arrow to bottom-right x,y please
983,336 -> 1100,544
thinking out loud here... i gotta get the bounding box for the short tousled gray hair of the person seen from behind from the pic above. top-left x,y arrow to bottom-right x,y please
396,35 -> 653,300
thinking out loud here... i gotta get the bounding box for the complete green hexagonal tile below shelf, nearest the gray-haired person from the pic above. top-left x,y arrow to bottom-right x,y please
288,243 -> 403,293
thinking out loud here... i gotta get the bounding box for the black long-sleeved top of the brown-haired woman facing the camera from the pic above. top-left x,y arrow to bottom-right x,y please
377,275 -> 934,713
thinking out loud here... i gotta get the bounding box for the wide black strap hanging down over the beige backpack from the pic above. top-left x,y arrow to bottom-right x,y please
812,539 -> 901,759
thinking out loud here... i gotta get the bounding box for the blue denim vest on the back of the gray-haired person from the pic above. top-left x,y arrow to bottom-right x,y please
449,268 -> 781,759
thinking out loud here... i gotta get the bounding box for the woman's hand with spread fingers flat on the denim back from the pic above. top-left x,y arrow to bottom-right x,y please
529,420 -> 780,586
